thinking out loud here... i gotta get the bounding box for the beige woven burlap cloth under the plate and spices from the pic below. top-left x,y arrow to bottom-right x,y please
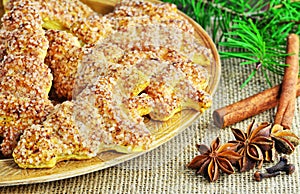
0,41 -> 300,194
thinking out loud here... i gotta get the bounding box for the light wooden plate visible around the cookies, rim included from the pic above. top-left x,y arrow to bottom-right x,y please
0,0 -> 221,186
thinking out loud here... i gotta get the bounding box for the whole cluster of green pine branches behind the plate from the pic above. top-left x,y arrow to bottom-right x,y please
164,0 -> 300,87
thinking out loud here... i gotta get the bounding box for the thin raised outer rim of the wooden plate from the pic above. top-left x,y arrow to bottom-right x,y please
0,0 -> 221,187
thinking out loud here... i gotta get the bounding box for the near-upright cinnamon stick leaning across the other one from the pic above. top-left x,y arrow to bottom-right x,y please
274,34 -> 299,129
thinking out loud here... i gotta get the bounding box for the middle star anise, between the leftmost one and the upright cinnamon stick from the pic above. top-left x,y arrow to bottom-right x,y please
229,121 -> 273,172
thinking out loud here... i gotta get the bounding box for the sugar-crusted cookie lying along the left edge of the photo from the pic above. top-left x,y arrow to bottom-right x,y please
0,1 -> 53,156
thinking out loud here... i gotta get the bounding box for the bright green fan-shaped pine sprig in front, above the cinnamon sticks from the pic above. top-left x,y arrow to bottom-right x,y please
219,19 -> 287,87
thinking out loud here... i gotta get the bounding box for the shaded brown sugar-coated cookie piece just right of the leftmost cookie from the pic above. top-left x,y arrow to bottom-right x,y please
45,30 -> 83,100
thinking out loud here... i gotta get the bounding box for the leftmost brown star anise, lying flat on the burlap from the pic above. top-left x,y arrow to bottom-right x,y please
188,138 -> 242,182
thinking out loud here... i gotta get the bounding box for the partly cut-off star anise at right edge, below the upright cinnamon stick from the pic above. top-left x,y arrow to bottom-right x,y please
270,124 -> 300,154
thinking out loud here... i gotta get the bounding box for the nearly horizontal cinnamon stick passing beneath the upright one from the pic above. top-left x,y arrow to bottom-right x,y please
213,79 -> 300,128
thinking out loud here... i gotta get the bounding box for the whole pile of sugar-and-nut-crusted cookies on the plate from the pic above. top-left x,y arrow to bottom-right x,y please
0,0 -> 213,168
